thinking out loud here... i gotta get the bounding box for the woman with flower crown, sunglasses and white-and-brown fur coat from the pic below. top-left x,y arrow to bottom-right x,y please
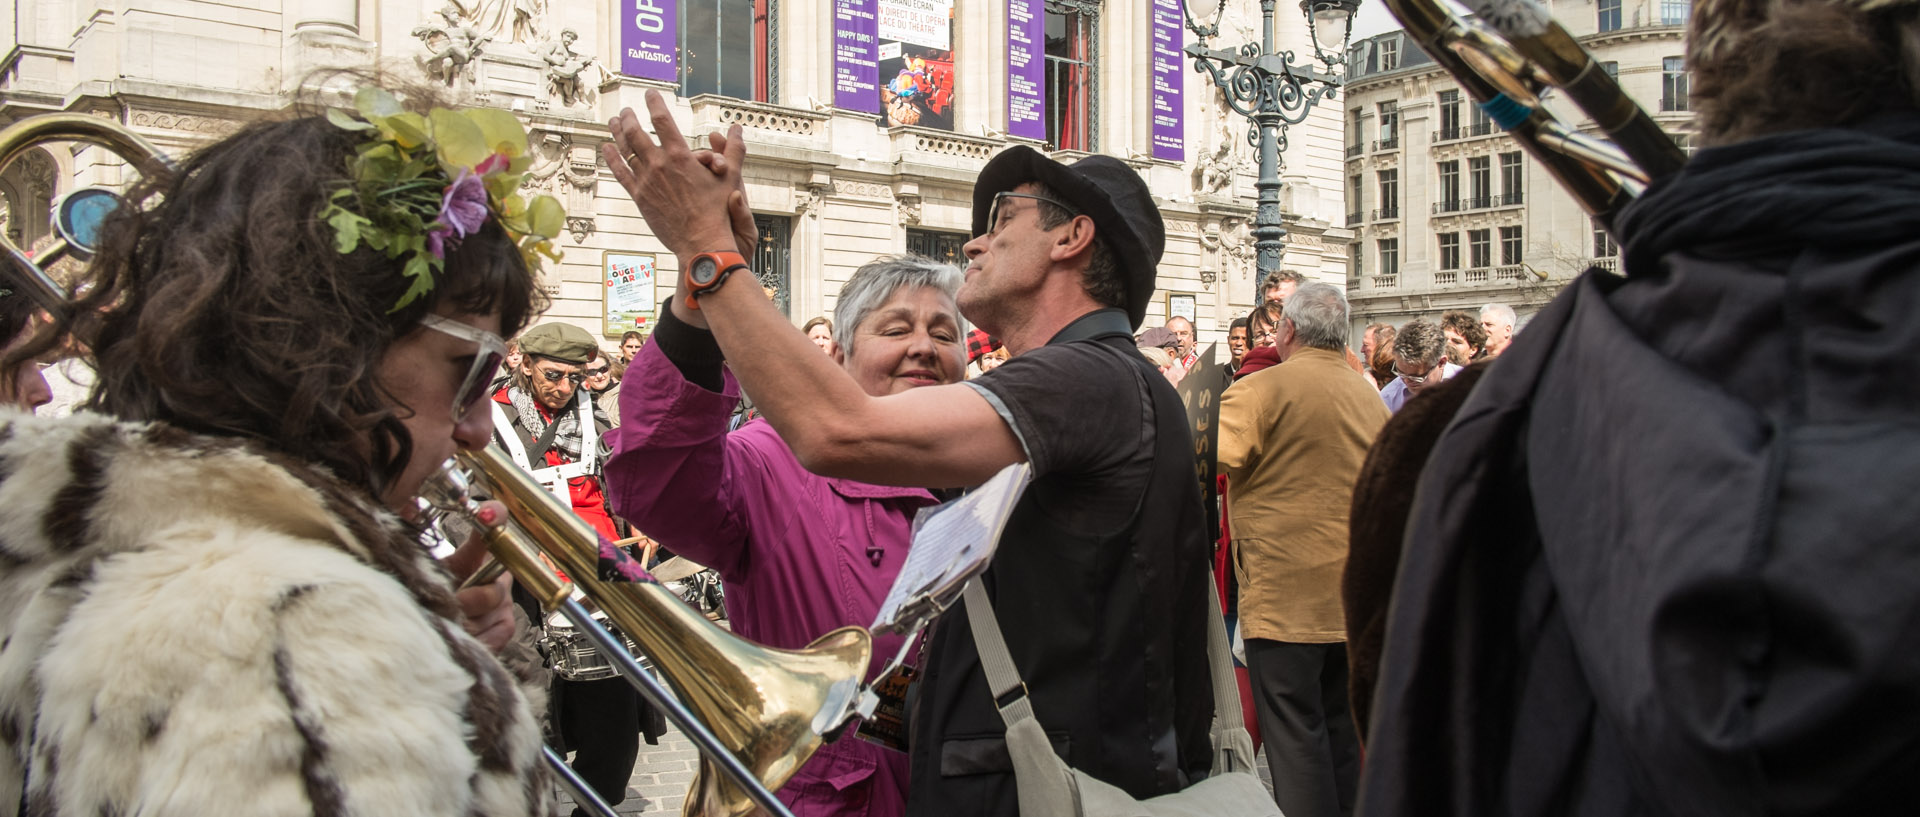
0,88 -> 563,817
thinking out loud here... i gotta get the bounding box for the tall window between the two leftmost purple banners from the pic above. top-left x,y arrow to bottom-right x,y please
680,0 -> 772,102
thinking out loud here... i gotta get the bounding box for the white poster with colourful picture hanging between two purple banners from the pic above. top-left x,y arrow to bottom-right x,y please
876,0 -> 954,130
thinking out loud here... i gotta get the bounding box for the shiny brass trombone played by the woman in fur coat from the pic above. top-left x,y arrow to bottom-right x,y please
0,113 -> 872,817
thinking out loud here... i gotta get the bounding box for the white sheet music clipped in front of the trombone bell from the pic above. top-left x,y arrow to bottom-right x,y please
870,462 -> 1033,633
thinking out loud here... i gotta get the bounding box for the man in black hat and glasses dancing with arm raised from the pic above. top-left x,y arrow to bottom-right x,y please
607,92 -> 1213,815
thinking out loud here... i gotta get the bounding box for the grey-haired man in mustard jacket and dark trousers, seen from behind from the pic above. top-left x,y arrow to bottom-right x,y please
1219,284 -> 1390,817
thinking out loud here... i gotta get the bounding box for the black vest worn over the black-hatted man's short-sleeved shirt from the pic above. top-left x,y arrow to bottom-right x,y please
908,311 -> 1213,815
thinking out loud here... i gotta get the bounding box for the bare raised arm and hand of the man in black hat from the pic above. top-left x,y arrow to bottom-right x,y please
607,92 -> 1025,487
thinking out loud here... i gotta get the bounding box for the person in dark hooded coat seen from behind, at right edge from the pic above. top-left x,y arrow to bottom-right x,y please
1359,0 -> 1920,817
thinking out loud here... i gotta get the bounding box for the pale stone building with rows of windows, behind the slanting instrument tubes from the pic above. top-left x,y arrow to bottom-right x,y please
1344,0 -> 1692,338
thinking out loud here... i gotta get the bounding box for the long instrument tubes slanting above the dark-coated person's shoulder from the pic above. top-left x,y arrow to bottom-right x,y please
1386,0 -> 1686,228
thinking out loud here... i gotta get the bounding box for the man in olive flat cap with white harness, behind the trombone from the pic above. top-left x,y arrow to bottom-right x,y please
492,322 -> 657,813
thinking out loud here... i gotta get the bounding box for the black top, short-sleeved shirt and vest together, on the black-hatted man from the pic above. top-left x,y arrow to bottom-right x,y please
908,311 -> 1213,815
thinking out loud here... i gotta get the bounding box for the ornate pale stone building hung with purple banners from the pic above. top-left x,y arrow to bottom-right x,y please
0,0 -> 1352,347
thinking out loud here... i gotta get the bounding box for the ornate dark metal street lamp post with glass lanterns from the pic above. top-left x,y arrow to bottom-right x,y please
1181,0 -> 1359,280
